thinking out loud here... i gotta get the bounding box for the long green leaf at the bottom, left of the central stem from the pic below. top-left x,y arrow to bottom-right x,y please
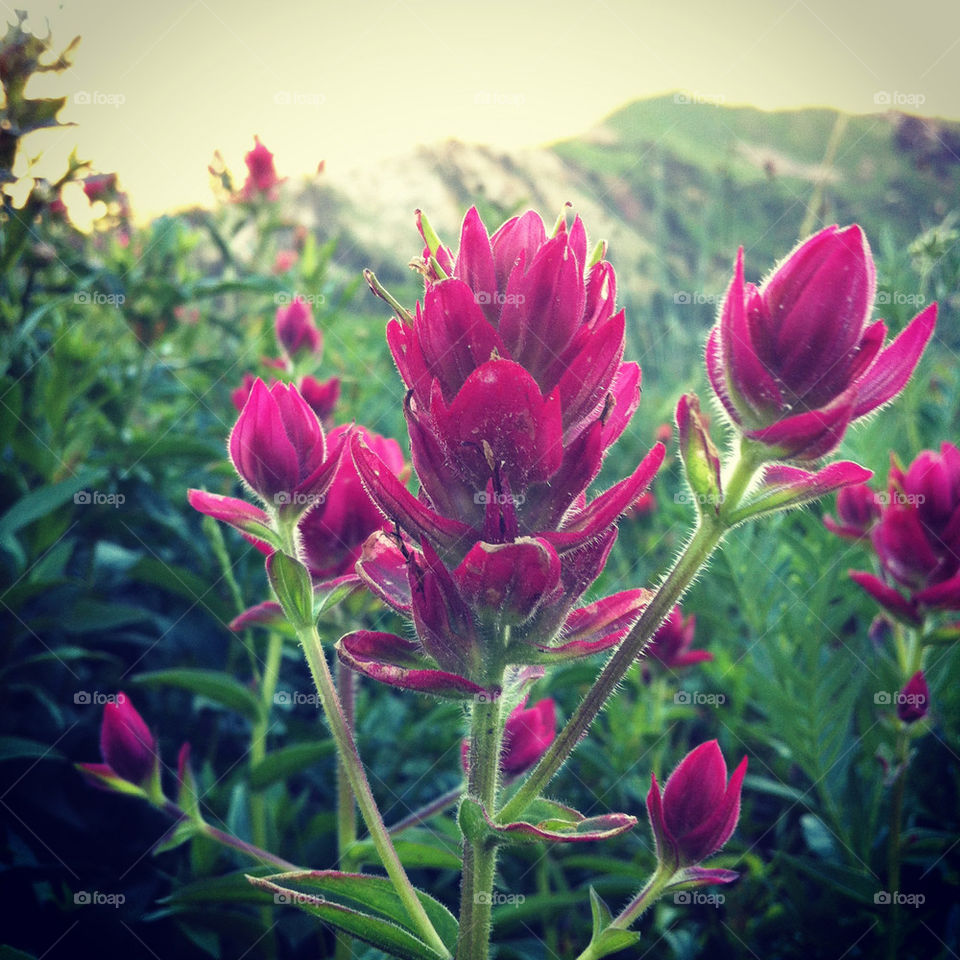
248,870 -> 457,960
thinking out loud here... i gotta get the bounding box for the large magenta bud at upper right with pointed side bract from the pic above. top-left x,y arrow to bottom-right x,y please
707,224 -> 937,460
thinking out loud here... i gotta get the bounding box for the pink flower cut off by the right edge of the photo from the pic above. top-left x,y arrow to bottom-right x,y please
850,443 -> 960,623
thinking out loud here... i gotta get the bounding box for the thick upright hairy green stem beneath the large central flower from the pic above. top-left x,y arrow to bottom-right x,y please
457,697 -> 503,960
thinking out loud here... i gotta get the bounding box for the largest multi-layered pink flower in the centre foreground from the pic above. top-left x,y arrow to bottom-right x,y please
339,209 -> 664,696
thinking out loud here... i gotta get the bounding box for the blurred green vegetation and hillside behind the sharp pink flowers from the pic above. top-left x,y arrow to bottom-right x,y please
0,13 -> 960,960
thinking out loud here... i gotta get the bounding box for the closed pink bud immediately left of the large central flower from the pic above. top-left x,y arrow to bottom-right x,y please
229,380 -> 343,512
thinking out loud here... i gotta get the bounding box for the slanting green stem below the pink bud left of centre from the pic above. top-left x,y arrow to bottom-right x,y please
297,626 -> 450,957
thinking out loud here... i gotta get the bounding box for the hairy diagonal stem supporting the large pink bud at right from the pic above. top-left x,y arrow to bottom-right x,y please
496,445 -> 759,823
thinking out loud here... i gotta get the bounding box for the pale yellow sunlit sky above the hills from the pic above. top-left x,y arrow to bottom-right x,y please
20,0 -> 960,218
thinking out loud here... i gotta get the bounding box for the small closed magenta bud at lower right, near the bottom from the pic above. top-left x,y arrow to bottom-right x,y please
647,740 -> 747,883
